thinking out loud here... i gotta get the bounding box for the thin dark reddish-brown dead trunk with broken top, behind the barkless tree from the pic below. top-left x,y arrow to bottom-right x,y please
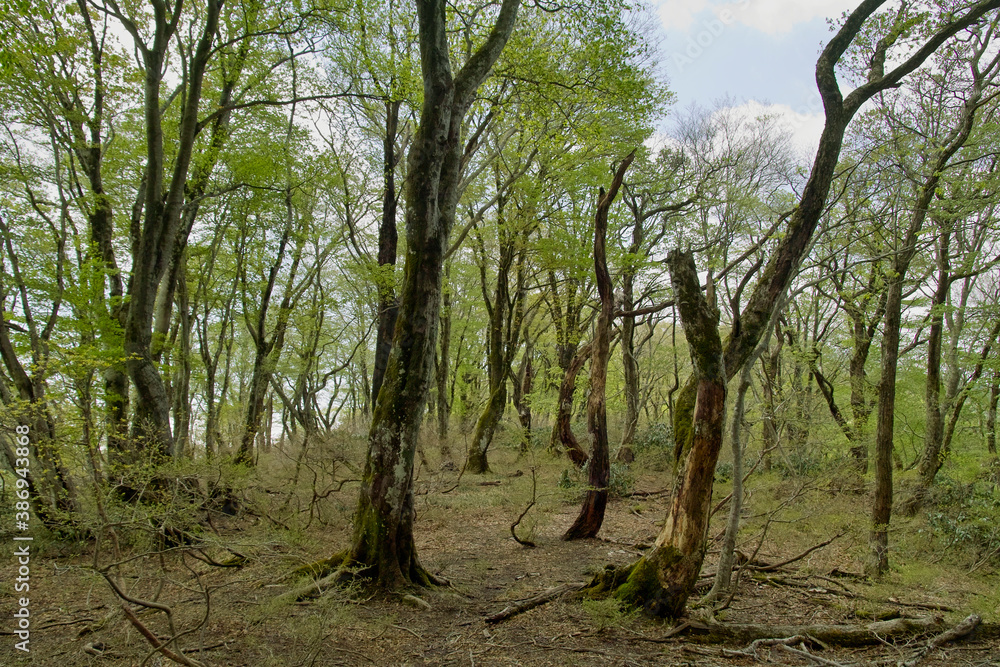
563,151 -> 635,540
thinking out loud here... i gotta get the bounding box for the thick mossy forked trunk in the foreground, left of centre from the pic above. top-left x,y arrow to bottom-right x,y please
343,0 -> 520,589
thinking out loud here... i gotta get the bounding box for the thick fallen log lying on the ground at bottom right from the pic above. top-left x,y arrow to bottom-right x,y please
691,616 -> 944,646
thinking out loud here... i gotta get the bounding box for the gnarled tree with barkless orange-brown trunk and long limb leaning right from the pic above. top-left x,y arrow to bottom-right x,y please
589,0 -> 1000,616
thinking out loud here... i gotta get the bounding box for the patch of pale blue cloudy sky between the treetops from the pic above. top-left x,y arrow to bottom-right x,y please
651,0 -> 859,153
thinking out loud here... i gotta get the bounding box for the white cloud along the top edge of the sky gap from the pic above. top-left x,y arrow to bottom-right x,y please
657,0 -> 859,35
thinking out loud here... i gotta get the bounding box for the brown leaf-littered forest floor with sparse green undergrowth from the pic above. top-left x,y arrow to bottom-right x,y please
0,436 -> 1000,667
